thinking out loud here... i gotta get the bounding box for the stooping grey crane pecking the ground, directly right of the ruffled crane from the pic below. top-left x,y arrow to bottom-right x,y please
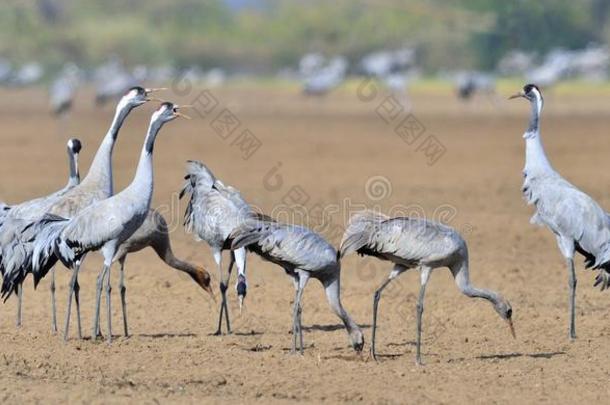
230,219 -> 364,354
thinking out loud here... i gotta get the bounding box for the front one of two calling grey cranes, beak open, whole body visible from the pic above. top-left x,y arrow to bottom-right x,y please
32,102 -> 182,342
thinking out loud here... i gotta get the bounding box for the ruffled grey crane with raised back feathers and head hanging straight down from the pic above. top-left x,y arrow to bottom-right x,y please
180,160 -> 248,335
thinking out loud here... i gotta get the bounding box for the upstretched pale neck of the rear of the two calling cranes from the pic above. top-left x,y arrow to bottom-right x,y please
82,102 -> 132,196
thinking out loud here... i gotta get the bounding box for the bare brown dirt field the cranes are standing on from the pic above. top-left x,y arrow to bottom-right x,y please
0,83 -> 610,403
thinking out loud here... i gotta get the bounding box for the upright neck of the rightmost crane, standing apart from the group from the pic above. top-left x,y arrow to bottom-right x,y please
523,90 -> 553,176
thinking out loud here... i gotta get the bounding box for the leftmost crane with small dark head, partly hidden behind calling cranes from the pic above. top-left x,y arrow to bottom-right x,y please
0,138 -> 81,331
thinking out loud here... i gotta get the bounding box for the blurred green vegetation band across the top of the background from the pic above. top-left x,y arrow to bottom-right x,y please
0,0 -> 610,72
